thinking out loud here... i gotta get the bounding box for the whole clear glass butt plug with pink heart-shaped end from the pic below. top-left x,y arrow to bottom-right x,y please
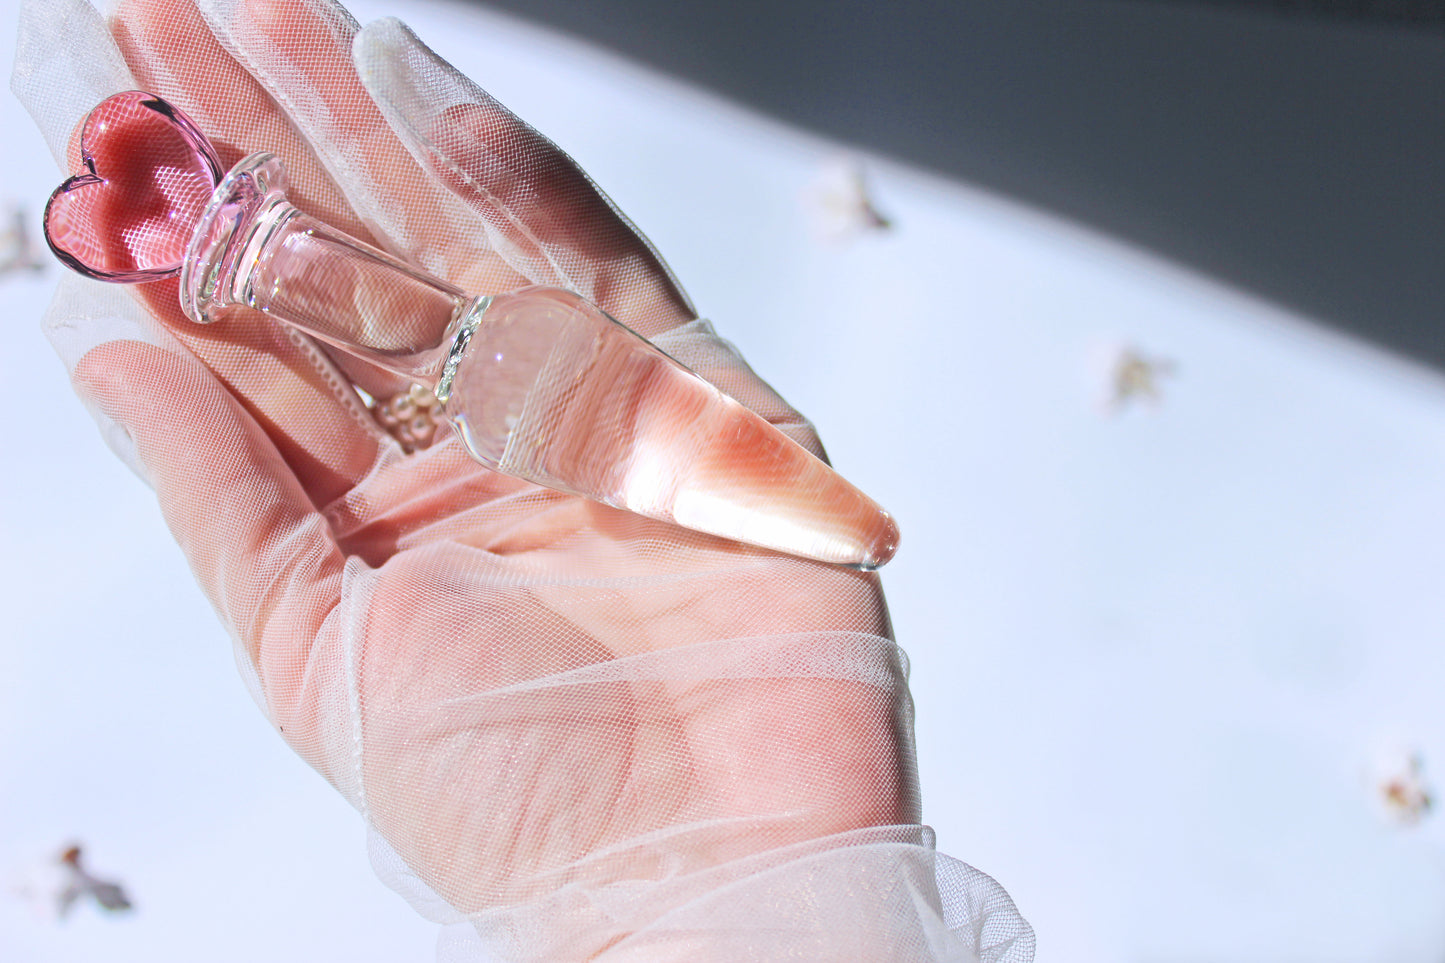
45,91 -> 899,568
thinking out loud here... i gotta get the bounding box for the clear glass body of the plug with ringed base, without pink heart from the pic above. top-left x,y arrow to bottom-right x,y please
182,155 -> 897,568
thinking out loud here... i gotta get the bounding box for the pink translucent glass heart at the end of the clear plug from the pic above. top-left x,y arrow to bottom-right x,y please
45,90 -> 223,282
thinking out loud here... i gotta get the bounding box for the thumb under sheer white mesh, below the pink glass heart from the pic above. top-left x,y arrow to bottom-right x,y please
74,341 -> 344,707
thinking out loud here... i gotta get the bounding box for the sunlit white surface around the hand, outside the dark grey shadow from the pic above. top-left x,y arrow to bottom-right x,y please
0,0 -> 1445,963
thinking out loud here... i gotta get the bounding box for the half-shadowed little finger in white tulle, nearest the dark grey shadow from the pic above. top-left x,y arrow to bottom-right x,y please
355,19 -> 694,335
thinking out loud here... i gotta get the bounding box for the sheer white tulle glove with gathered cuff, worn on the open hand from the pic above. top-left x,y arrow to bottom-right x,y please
13,0 -> 1033,963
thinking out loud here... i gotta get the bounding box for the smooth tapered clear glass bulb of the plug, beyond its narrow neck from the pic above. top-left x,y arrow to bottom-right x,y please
445,288 -> 899,568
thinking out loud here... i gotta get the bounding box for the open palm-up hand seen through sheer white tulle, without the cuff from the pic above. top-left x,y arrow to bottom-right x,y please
31,0 -> 918,959
